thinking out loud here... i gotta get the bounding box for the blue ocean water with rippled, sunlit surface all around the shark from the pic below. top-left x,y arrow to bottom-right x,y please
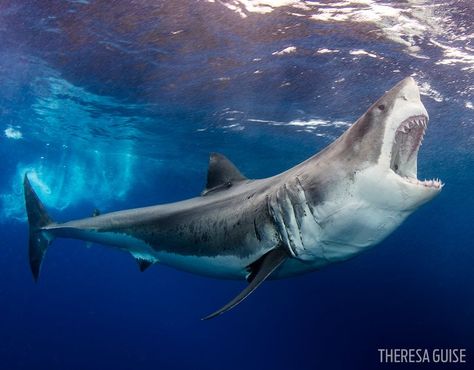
0,0 -> 474,369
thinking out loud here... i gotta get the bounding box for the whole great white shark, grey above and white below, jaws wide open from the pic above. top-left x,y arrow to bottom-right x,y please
24,77 -> 443,318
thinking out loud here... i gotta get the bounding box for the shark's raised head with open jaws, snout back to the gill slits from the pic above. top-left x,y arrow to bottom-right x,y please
296,77 -> 443,263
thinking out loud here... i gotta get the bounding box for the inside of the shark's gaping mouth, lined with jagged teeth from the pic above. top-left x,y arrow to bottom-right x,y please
390,115 -> 443,188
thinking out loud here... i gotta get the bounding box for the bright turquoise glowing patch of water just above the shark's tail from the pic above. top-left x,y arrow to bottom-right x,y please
0,151 -> 136,220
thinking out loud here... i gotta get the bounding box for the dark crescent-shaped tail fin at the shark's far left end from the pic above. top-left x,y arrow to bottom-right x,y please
23,174 -> 53,281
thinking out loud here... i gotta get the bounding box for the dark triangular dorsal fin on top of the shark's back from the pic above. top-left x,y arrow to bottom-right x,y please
201,153 -> 247,195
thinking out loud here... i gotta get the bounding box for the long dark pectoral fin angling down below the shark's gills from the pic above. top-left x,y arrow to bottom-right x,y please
202,247 -> 289,320
